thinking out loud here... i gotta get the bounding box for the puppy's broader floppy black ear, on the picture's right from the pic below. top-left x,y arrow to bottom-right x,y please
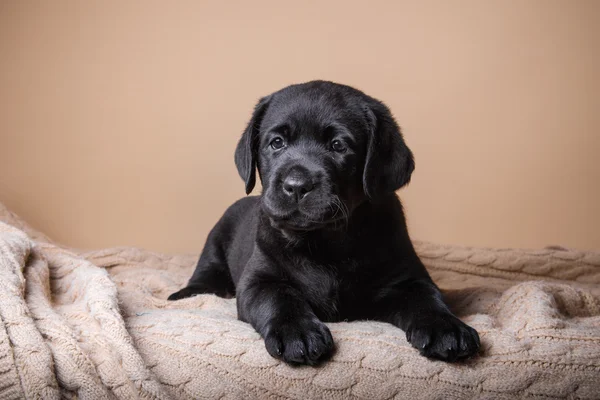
363,99 -> 415,198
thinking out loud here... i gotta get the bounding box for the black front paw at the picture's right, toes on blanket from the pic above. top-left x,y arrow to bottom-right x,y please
406,314 -> 480,362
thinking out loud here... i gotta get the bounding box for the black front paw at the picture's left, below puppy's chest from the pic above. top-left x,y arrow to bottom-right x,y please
264,318 -> 335,365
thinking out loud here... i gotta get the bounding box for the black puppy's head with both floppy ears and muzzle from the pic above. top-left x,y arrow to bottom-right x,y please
235,81 -> 414,231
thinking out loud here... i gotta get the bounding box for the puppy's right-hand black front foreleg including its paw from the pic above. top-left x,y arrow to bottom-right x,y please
378,278 -> 480,362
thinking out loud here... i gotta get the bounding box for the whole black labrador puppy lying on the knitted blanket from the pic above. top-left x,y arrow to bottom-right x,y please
169,81 -> 479,365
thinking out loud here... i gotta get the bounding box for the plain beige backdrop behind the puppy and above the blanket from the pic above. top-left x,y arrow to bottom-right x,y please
0,0 -> 600,251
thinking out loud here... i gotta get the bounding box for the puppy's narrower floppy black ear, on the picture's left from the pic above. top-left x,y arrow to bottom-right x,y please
235,96 -> 271,194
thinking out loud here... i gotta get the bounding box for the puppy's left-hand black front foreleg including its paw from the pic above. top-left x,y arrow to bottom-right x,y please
237,272 -> 334,365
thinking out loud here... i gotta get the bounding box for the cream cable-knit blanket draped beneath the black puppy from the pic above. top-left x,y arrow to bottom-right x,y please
0,204 -> 600,399
